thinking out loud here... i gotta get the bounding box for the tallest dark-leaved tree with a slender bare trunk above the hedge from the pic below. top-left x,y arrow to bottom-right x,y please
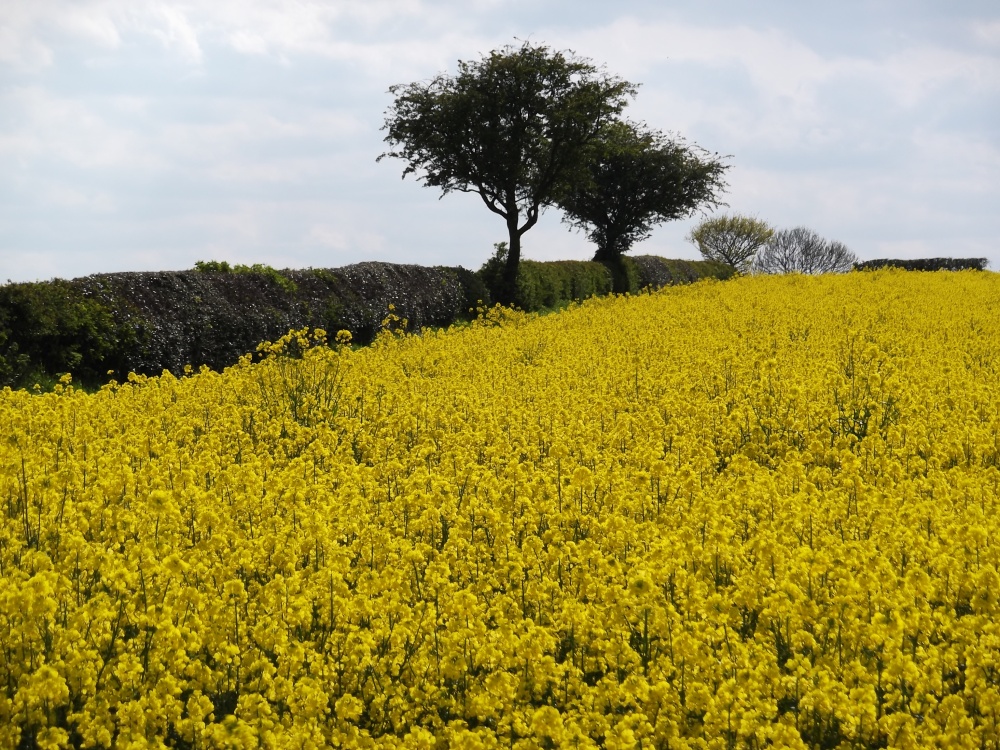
379,42 -> 636,303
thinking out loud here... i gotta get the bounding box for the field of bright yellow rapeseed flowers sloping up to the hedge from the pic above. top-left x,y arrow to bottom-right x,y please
0,271 -> 1000,750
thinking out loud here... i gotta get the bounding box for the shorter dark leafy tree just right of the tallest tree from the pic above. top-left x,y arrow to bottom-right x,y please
557,121 -> 728,291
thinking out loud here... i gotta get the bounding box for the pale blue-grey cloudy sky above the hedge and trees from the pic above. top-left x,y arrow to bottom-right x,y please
0,0 -> 1000,282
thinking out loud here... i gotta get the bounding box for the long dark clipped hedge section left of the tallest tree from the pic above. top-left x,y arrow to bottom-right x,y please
0,263 -> 489,387
